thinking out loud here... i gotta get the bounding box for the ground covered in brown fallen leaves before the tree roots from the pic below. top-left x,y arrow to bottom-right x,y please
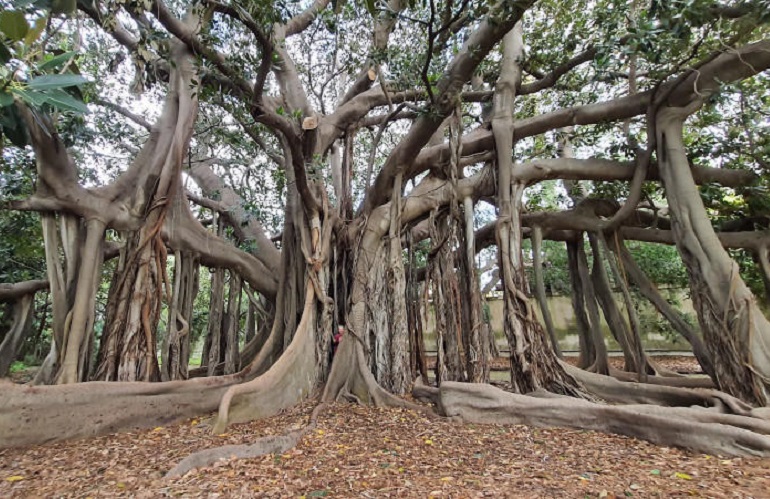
0,358 -> 770,498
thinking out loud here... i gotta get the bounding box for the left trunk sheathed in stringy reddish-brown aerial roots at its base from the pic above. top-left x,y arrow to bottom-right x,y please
95,41 -> 200,381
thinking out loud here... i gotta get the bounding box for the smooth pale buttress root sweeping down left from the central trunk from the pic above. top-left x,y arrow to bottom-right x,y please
213,280 -> 319,434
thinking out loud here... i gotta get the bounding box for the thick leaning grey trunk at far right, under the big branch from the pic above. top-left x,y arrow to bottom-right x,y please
656,103 -> 770,405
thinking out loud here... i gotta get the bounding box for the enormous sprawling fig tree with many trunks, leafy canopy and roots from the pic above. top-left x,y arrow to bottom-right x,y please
0,0 -> 770,454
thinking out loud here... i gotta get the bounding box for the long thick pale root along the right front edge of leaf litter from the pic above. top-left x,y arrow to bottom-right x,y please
415,382 -> 770,456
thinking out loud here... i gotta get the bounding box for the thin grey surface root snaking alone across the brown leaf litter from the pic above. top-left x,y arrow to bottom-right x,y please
165,404 -> 327,478
